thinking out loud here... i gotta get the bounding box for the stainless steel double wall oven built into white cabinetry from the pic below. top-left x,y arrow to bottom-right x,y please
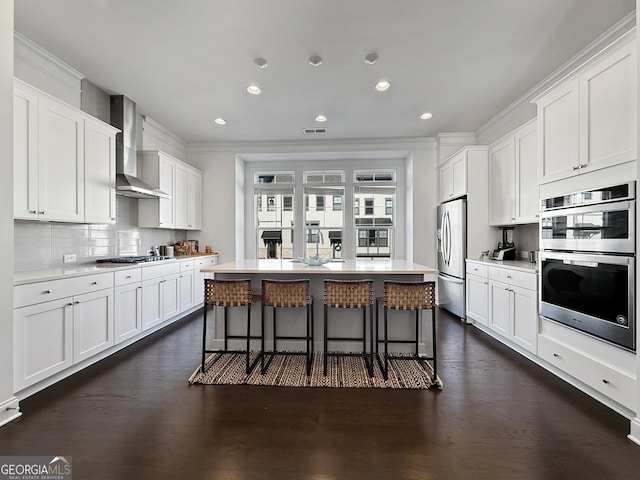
540,182 -> 636,351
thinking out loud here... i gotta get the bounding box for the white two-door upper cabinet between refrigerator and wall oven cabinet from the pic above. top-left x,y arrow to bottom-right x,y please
489,120 -> 539,225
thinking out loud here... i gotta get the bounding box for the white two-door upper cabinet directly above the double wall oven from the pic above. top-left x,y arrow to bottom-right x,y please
536,38 -> 637,183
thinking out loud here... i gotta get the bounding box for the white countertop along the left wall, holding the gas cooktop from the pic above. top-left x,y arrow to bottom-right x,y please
13,254 -> 220,285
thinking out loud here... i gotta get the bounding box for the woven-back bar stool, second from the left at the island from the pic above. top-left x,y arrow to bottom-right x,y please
261,279 -> 313,376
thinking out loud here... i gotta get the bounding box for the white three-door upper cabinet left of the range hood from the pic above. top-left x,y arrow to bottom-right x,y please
14,80 -> 117,223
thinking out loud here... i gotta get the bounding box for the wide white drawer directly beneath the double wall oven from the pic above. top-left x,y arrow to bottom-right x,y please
538,335 -> 636,410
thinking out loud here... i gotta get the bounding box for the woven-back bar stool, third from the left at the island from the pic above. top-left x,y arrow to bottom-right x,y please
324,280 -> 373,377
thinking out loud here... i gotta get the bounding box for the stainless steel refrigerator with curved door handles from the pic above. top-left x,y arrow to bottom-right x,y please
437,198 -> 467,319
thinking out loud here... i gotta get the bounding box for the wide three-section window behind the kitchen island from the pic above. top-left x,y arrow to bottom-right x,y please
245,166 -> 404,259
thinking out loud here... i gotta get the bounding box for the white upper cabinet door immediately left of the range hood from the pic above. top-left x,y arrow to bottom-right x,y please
84,120 -> 116,223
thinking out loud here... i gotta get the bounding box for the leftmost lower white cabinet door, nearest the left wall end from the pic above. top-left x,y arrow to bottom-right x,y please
13,298 -> 73,392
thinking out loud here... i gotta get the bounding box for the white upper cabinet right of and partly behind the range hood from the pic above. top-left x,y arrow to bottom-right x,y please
138,151 -> 202,230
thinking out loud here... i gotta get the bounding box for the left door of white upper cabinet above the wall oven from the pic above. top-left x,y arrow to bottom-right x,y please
538,80 -> 579,183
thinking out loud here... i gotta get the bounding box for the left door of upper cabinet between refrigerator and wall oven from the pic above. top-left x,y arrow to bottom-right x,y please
489,137 -> 516,225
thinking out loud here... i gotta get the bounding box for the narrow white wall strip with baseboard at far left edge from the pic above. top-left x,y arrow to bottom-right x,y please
0,0 -> 19,425
